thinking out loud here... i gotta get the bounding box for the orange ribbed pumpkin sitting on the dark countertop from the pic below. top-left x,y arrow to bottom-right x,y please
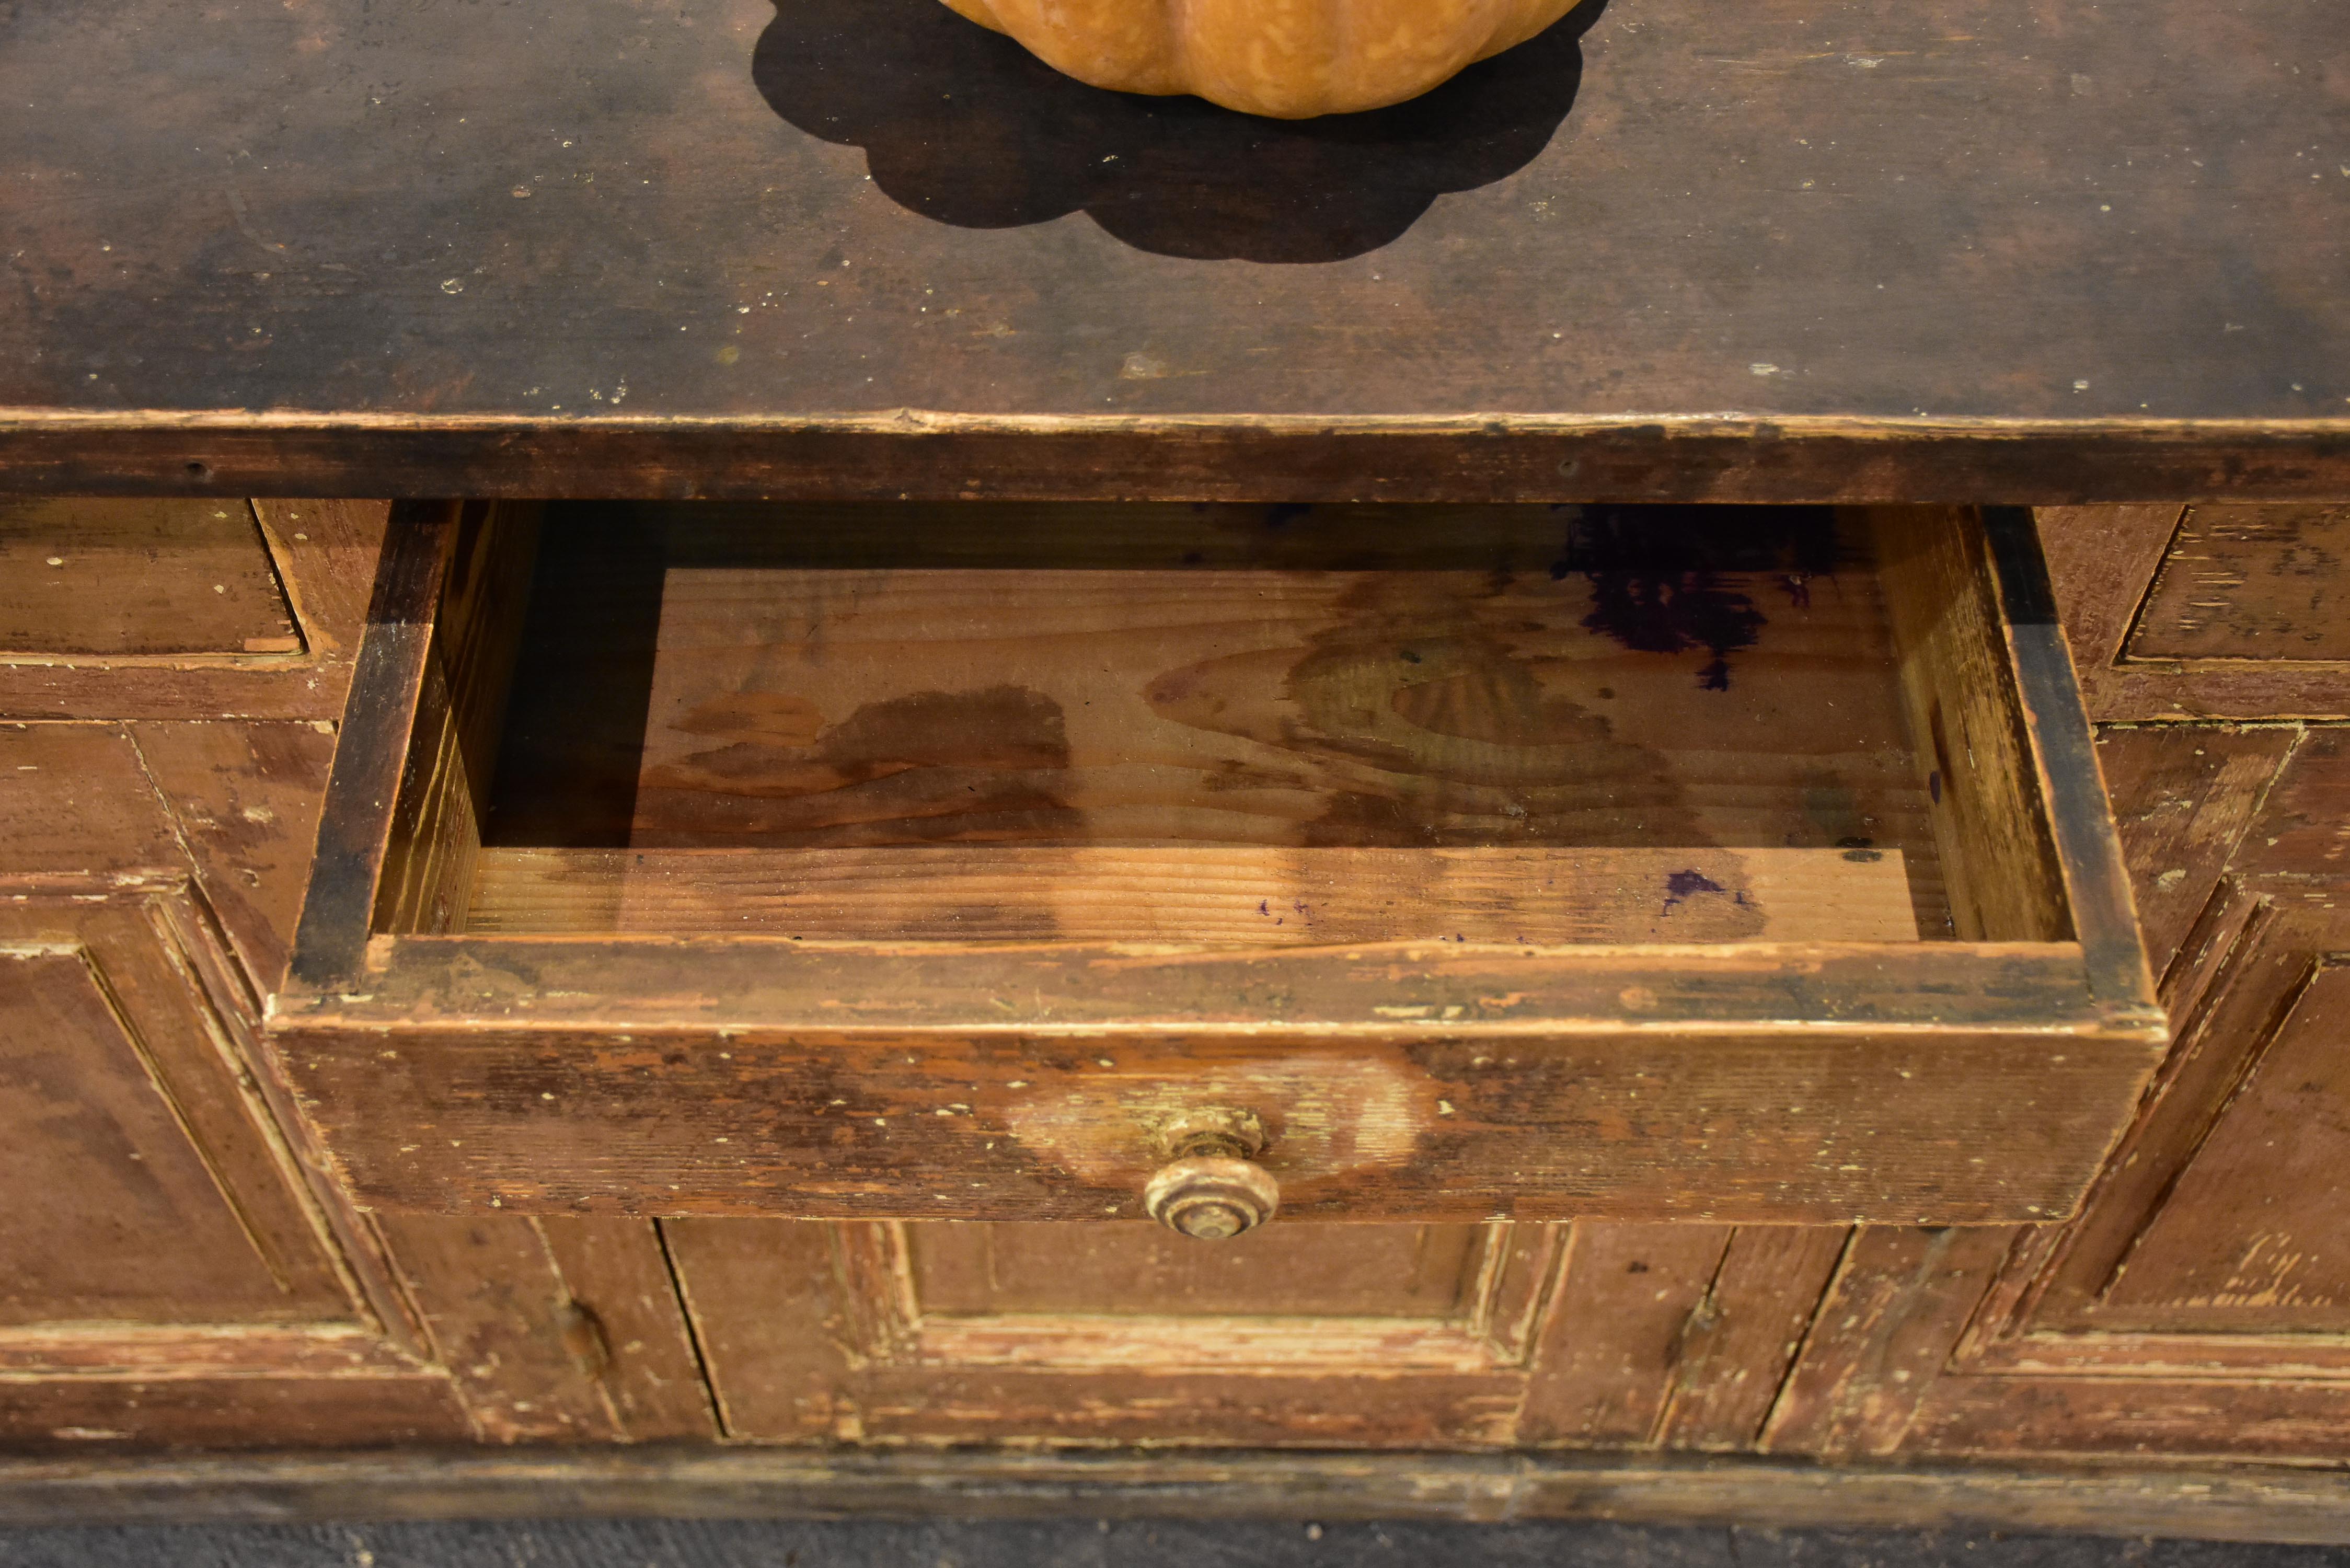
947,0 -> 1574,120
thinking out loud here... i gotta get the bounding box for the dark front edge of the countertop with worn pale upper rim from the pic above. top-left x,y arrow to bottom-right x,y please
18,423 -> 2350,510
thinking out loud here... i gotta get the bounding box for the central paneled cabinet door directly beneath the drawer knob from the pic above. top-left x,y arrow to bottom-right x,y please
663,1220 -> 1842,1448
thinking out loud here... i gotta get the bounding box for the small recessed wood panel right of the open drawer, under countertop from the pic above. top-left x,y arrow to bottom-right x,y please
2127,505 -> 2350,663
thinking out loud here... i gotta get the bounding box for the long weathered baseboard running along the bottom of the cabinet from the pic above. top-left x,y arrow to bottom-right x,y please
0,1448 -> 2350,1544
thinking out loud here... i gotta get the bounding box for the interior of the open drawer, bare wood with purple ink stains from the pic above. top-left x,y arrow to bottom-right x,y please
395,503 -> 2070,948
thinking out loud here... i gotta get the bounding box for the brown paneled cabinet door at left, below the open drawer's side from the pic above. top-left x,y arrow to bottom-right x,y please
0,891 -> 468,1448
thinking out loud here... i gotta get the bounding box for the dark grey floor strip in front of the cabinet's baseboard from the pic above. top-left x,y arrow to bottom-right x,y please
0,1519 -> 2350,1568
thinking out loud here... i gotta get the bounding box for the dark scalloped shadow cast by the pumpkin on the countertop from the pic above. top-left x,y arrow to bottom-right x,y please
752,0 -> 1607,263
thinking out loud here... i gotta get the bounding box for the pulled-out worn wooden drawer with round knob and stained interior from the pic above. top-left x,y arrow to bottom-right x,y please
273,505 -> 2164,1234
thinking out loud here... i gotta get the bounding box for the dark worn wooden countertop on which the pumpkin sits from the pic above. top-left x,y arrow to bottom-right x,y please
0,0 -> 2350,501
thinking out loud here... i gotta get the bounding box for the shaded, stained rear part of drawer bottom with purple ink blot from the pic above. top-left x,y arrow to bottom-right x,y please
487,508 -> 1934,907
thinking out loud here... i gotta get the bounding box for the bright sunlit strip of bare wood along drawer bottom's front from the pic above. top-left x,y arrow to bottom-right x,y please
465,846 -> 1918,948
